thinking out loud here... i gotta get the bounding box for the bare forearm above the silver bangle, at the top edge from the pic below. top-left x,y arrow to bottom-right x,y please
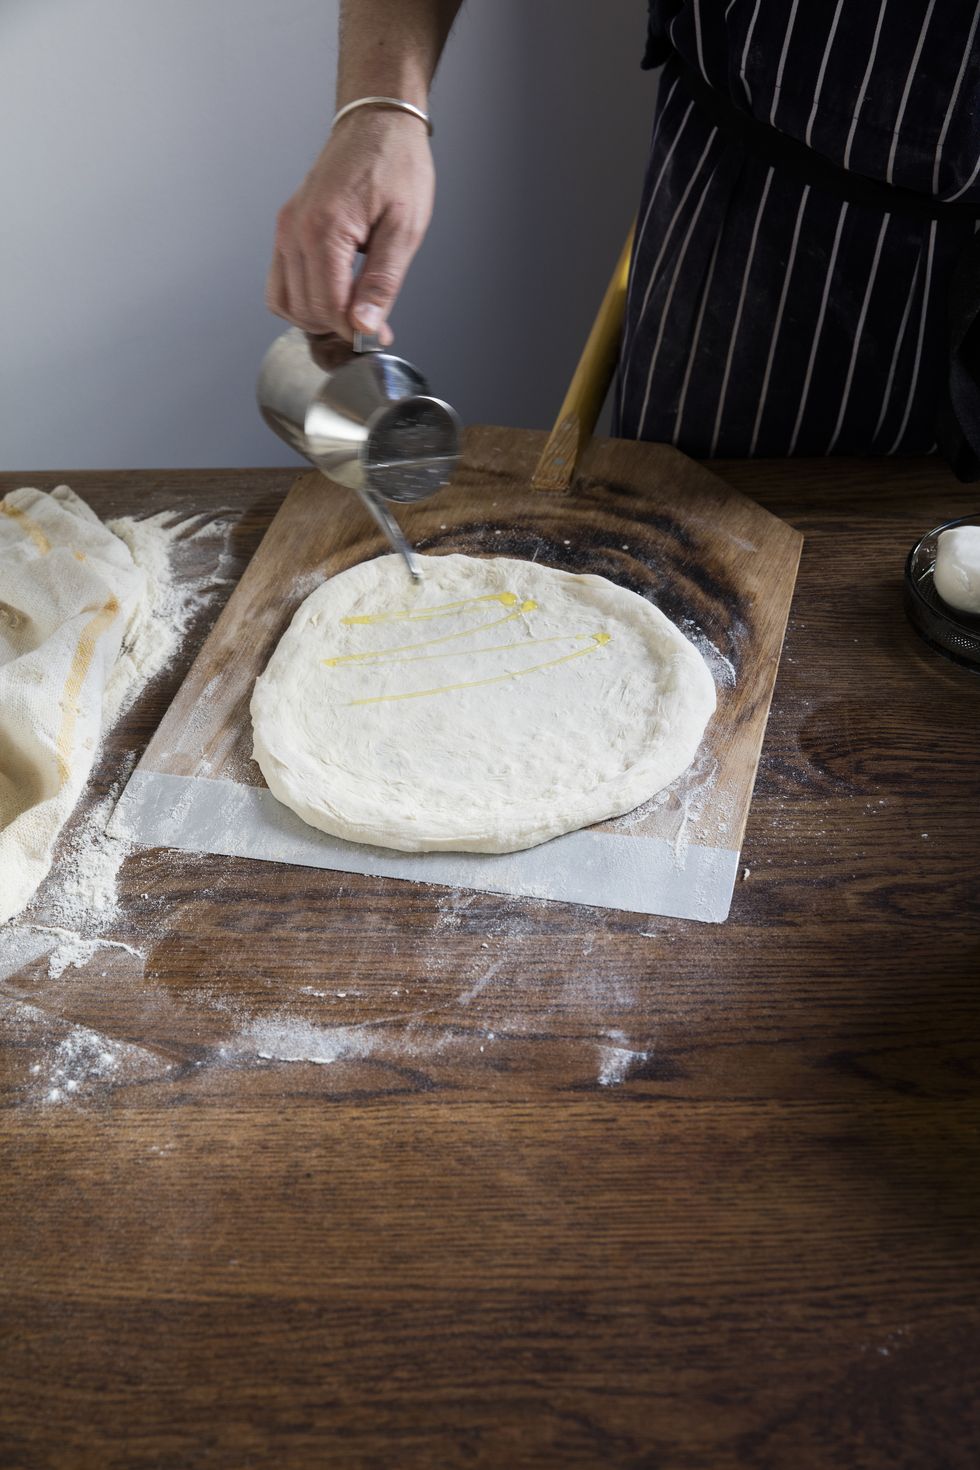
336,0 -> 461,107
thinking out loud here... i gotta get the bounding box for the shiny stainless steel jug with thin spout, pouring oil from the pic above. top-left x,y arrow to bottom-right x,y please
259,326 -> 460,579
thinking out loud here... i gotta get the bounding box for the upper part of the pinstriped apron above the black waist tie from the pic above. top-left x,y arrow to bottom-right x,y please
646,0 -> 980,201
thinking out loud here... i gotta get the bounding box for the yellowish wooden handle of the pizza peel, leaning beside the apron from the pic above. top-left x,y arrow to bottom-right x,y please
530,226 -> 633,491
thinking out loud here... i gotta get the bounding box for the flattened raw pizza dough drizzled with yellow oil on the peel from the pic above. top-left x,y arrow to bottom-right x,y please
251,556 -> 716,853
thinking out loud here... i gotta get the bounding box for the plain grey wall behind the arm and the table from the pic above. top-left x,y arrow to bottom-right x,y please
0,0 -> 655,469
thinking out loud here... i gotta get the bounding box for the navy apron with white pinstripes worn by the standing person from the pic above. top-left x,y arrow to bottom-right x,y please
614,0 -> 980,457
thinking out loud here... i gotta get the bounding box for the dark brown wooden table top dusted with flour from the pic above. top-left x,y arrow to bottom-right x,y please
0,460 -> 980,1470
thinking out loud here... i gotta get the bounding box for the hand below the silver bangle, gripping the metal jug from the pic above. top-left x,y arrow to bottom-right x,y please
266,107 -> 435,345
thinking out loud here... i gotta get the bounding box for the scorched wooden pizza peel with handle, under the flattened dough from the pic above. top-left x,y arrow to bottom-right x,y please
113,229 -> 802,922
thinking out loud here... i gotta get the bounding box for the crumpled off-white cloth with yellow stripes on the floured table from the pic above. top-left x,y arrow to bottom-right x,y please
0,485 -> 145,923
